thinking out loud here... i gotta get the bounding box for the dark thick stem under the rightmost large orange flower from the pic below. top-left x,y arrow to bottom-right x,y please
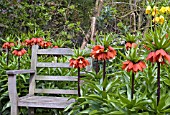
157,62 -> 160,105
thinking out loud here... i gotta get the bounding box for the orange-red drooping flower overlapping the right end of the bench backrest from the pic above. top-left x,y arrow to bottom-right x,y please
70,56 -> 90,68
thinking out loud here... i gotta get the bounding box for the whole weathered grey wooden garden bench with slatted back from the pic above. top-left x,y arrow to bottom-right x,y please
6,45 -> 91,115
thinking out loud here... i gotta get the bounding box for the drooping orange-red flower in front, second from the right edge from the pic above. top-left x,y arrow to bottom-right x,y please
122,60 -> 146,73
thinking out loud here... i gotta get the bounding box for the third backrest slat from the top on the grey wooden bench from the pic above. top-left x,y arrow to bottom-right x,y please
35,76 -> 77,81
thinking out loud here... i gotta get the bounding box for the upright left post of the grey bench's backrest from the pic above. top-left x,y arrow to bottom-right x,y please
29,45 -> 38,95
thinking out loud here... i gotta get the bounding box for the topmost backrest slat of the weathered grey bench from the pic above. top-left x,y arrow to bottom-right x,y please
38,48 -> 73,55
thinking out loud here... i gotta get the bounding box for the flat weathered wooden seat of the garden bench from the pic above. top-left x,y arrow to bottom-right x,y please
18,96 -> 75,108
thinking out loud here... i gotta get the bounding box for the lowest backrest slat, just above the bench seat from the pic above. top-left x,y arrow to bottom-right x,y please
35,89 -> 77,94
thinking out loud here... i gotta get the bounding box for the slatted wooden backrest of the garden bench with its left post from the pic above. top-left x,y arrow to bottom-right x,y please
29,45 -> 84,95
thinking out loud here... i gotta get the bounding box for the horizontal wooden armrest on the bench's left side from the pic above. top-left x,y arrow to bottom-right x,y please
6,69 -> 35,75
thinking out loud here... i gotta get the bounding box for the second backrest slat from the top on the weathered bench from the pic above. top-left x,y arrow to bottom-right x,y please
37,62 -> 72,68
